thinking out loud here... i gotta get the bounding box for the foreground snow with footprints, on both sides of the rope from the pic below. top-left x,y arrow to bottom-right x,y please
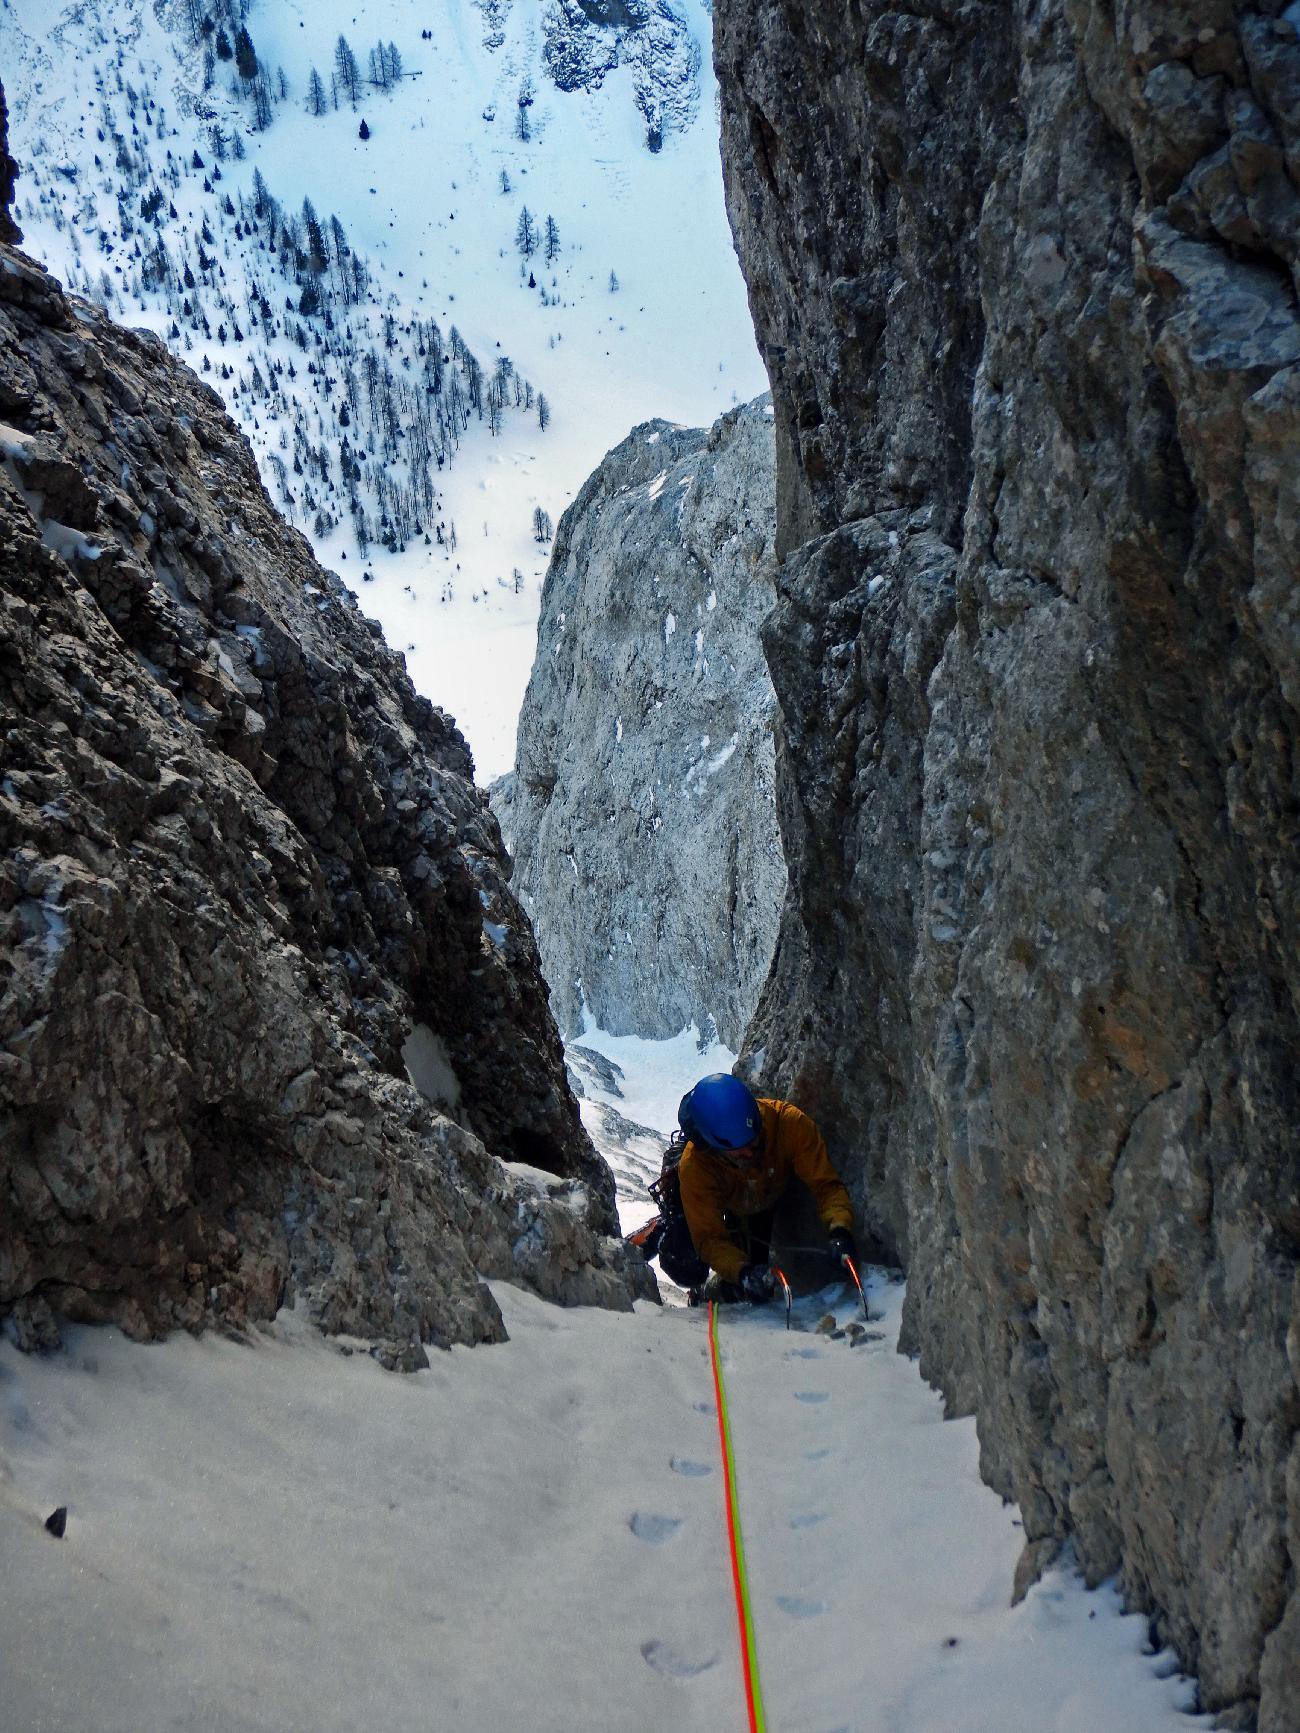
0,1277 -> 1208,1733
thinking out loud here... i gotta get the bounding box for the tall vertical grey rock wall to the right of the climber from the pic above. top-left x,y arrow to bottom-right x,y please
716,0 -> 1300,1733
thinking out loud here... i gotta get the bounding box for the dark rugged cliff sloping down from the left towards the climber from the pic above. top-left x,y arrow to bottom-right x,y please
0,87 -> 643,1360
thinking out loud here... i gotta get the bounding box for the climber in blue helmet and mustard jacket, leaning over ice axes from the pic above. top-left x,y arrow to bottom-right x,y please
678,1071 -> 858,1301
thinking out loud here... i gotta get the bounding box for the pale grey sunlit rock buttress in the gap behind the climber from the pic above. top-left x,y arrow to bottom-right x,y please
494,400 -> 785,1048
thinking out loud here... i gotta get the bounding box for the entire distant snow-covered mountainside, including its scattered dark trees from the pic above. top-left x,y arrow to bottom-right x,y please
0,0 -> 766,778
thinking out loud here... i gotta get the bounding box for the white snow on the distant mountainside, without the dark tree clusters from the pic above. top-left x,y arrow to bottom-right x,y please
0,0 -> 766,780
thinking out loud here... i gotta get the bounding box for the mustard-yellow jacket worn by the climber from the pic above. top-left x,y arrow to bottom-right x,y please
678,1100 -> 853,1282
